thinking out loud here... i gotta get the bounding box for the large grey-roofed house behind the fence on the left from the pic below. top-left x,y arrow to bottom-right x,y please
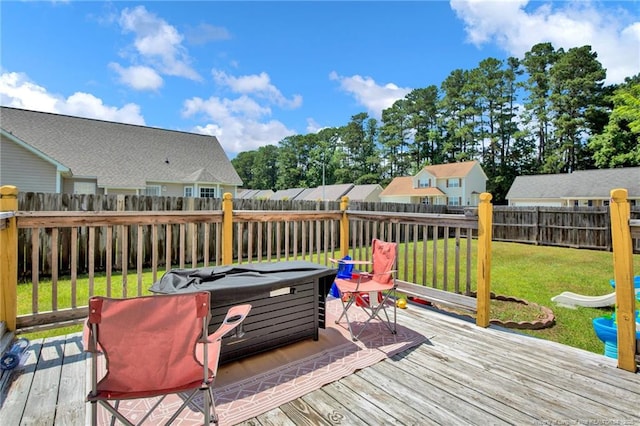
0,107 -> 242,197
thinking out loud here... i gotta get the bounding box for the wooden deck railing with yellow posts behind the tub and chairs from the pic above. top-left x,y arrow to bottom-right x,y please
0,186 -> 492,332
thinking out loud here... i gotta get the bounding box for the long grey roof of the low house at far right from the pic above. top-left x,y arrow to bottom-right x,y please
507,167 -> 640,200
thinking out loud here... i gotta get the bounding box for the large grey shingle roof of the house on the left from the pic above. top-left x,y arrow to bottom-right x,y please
0,107 -> 242,188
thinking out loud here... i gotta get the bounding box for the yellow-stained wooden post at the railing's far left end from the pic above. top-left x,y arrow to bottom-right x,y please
0,185 -> 18,331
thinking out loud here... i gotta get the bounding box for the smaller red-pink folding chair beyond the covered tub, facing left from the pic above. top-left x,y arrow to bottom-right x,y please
331,239 -> 398,341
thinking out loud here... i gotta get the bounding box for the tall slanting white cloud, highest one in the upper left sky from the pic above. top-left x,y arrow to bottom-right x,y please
118,6 -> 202,81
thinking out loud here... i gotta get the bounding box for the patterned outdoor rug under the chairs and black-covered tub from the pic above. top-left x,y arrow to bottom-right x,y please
94,299 -> 425,426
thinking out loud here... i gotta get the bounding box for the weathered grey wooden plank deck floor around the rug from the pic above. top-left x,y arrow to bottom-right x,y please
0,305 -> 640,425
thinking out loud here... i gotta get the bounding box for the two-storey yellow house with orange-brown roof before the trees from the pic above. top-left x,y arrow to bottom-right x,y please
380,161 -> 487,206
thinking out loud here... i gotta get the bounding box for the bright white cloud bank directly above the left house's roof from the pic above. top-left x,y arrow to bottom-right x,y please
0,72 -> 145,125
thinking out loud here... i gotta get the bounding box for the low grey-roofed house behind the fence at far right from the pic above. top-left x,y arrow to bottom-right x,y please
507,167 -> 640,207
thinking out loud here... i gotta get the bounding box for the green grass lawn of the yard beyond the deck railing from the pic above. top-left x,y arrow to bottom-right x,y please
18,241 -> 640,353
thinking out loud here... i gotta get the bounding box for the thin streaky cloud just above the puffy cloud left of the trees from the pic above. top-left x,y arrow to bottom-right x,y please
211,70 -> 302,109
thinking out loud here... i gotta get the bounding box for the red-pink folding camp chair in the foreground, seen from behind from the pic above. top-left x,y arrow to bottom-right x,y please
85,292 -> 251,425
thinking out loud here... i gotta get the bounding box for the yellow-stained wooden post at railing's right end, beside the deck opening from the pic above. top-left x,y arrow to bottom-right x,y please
476,192 -> 493,327
